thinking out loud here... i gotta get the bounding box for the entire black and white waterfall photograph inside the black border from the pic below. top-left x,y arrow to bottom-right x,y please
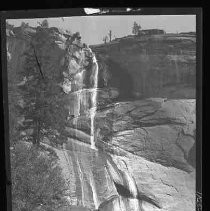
4,8 -> 202,211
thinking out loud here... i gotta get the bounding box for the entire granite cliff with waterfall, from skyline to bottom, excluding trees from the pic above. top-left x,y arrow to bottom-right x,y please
7,27 -> 196,211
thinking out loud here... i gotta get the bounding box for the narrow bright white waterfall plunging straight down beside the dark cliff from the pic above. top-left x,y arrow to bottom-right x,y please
90,52 -> 98,149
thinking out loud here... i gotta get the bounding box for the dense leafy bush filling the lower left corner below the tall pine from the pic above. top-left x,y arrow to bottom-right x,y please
10,142 -> 68,211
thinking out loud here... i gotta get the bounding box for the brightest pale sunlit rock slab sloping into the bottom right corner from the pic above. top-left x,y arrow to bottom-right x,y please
114,155 -> 195,211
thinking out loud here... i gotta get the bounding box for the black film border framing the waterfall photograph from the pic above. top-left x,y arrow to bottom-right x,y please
0,7 -> 203,211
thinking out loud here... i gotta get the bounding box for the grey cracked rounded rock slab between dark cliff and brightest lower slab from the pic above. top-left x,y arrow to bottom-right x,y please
98,99 -> 195,172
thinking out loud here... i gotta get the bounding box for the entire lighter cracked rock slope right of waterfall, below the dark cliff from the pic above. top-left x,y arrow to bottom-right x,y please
94,99 -> 196,211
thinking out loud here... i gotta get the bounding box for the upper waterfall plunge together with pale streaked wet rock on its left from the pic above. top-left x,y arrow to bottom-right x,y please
66,45 -> 98,149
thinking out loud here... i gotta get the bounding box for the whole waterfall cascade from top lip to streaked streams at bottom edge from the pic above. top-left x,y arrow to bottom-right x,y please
61,42 -> 146,211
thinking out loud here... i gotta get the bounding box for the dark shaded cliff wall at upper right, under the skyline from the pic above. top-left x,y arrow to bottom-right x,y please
91,35 -> 196,99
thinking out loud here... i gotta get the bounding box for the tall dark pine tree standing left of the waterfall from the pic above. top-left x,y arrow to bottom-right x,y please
19,25 -> 68,145
